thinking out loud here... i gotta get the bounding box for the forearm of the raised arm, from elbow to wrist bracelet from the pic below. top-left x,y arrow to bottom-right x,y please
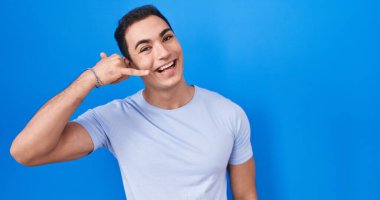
11,70 -> 95,162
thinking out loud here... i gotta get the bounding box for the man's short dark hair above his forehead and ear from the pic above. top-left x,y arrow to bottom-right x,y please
115,5 -> 172,60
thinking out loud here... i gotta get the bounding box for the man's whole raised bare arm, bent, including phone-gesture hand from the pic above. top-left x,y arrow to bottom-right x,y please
10,53 -> 147,166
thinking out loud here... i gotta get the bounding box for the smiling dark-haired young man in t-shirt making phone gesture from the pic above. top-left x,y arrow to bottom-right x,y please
11,6 -> 257,200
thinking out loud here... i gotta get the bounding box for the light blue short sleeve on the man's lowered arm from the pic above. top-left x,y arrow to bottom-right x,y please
228,106 -> 253,165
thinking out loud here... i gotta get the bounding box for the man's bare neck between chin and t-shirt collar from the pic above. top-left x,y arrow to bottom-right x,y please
143,82 -> 195,110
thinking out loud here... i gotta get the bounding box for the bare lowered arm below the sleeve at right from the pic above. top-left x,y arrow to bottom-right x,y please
228,157 -> 258,200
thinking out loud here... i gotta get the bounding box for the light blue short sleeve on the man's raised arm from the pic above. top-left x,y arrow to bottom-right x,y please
71,109 -> 111,151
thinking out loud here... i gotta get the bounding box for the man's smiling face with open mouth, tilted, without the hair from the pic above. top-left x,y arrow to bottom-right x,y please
125,15 -> 183,89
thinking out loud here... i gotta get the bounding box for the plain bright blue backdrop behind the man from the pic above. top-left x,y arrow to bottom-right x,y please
0,0 -> 380,200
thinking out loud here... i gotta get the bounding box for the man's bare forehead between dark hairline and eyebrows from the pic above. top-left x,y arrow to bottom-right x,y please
124,15 -> 169,46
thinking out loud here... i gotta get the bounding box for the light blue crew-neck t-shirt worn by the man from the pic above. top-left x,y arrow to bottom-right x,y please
73,85 -> 253,200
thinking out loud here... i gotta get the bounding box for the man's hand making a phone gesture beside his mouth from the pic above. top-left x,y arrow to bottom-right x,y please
92,52 -> 150,85
